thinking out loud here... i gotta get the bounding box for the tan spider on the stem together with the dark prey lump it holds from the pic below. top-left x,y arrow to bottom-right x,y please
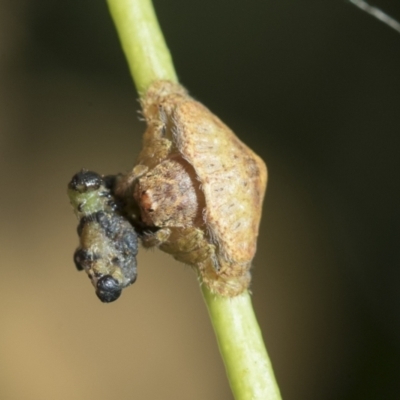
68,81 -> 267,302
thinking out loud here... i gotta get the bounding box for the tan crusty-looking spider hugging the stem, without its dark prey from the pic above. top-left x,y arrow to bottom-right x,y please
116,81 -> 267,297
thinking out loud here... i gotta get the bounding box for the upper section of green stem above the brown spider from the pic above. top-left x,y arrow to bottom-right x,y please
108,0 -> 178,96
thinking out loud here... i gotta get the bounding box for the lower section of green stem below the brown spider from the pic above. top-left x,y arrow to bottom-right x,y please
202,285 -> 281,400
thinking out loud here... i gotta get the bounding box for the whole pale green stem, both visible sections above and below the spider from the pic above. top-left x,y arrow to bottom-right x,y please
107,0 -> 281,400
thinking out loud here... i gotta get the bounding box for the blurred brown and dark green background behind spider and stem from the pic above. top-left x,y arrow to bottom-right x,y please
0,0 -> 400,400
